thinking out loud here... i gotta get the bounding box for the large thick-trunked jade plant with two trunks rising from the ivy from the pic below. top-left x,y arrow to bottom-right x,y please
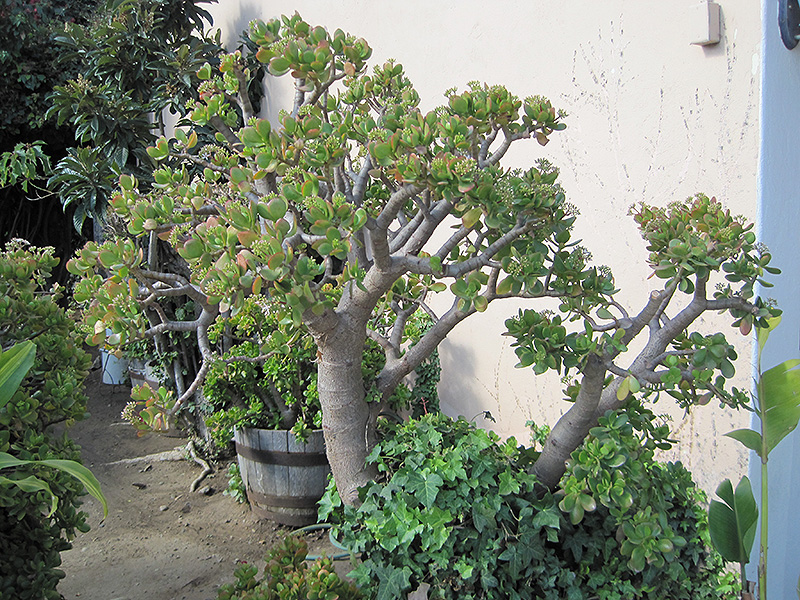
70,14 -> 775,502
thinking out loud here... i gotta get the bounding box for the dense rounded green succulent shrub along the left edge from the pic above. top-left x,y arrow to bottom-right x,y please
0,243 -> 90,600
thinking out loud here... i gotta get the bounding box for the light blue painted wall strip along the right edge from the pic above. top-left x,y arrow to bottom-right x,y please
749,0 -> 800,600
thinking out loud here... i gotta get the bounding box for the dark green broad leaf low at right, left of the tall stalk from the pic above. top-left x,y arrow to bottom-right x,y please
708,477 -> 758,564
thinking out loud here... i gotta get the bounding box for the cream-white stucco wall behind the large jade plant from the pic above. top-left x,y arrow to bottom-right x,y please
206,0 -> 761,490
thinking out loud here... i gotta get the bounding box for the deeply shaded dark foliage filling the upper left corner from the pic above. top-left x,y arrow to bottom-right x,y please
0,0 -> 98,283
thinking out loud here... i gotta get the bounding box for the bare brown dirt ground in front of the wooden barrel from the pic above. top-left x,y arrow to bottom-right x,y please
58,370 -> 340,600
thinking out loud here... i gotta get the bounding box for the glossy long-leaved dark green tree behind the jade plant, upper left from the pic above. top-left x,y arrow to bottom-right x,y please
47,0 -> 218,228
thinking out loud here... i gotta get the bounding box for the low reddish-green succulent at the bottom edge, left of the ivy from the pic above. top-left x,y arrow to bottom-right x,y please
217,536 -> 361,600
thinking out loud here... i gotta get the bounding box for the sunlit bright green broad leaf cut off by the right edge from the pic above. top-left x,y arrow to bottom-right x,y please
758,359 -> 800,454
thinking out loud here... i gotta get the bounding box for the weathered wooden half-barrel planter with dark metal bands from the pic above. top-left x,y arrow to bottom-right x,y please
234,428 -> 331,527
